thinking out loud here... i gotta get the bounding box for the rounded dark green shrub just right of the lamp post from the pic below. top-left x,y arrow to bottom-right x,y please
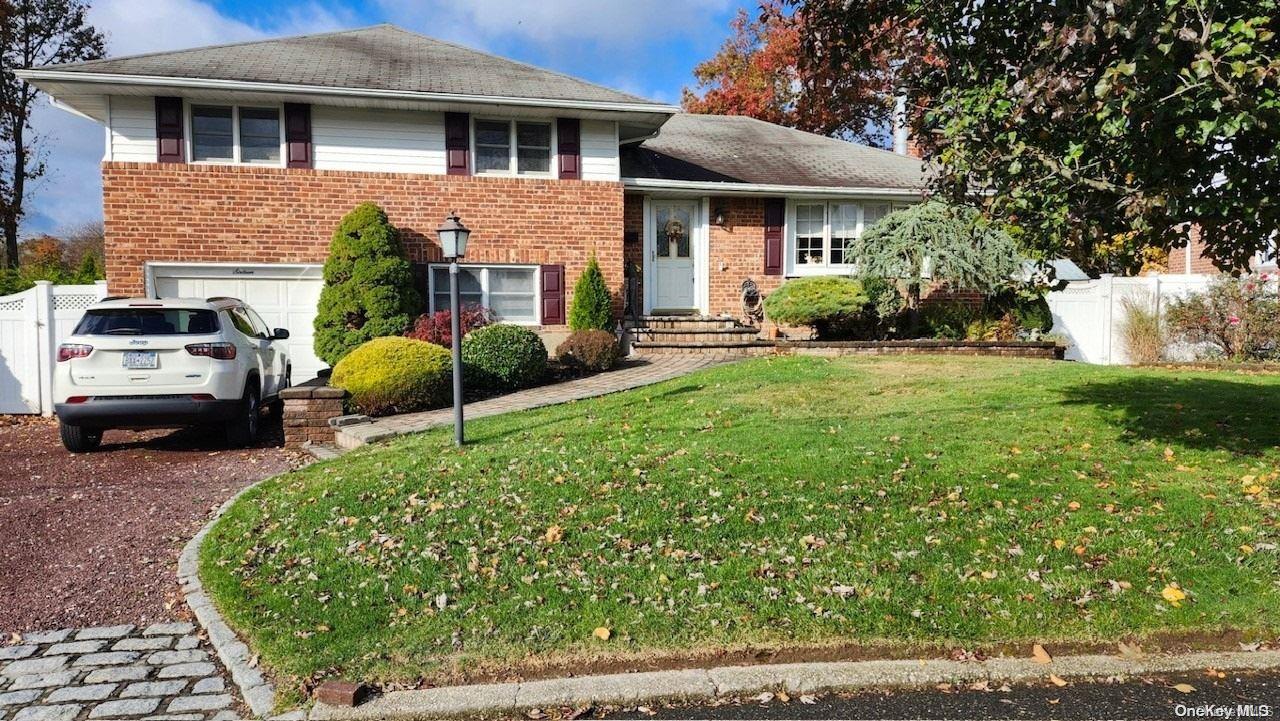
462,324 -> 547,391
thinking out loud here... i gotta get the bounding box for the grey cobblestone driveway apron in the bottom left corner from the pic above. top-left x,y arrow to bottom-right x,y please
0,622 -> 241,721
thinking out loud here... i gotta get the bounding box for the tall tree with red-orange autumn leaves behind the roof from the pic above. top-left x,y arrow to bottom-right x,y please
682,0 -> 895,145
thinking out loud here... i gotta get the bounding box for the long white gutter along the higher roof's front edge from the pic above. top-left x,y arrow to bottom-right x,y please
13,68 -> 681,115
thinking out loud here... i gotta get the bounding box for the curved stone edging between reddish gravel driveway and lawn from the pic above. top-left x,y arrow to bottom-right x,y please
178,479 -> 275,718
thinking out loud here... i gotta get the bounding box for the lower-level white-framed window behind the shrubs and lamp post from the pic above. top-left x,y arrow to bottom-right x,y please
431,265 -> 539,324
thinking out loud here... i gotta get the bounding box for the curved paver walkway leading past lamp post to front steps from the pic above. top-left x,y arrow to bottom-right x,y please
337,353 -> 741,448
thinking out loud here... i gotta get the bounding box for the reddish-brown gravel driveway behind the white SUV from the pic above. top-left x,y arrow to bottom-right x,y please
0,416 -> 302,631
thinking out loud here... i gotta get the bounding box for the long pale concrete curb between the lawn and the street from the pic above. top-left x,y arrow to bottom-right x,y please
310,651 -> 1280,721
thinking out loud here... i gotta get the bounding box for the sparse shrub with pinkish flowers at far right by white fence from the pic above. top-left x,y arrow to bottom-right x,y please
1165,274 -> 1280,361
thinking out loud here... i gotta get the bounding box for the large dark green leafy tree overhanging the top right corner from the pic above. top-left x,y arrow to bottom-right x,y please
792,0 -> 1280,276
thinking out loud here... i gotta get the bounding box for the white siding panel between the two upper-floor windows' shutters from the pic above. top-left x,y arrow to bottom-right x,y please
311,105 -> 445,174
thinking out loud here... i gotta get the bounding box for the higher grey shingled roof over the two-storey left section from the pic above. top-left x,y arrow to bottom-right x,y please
32,24 -> 673,110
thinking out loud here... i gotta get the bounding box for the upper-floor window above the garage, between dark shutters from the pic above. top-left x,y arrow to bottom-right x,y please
191,105 -> 280,165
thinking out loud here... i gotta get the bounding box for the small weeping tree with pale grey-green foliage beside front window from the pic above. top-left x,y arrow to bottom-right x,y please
845,200 -> 1020,329
